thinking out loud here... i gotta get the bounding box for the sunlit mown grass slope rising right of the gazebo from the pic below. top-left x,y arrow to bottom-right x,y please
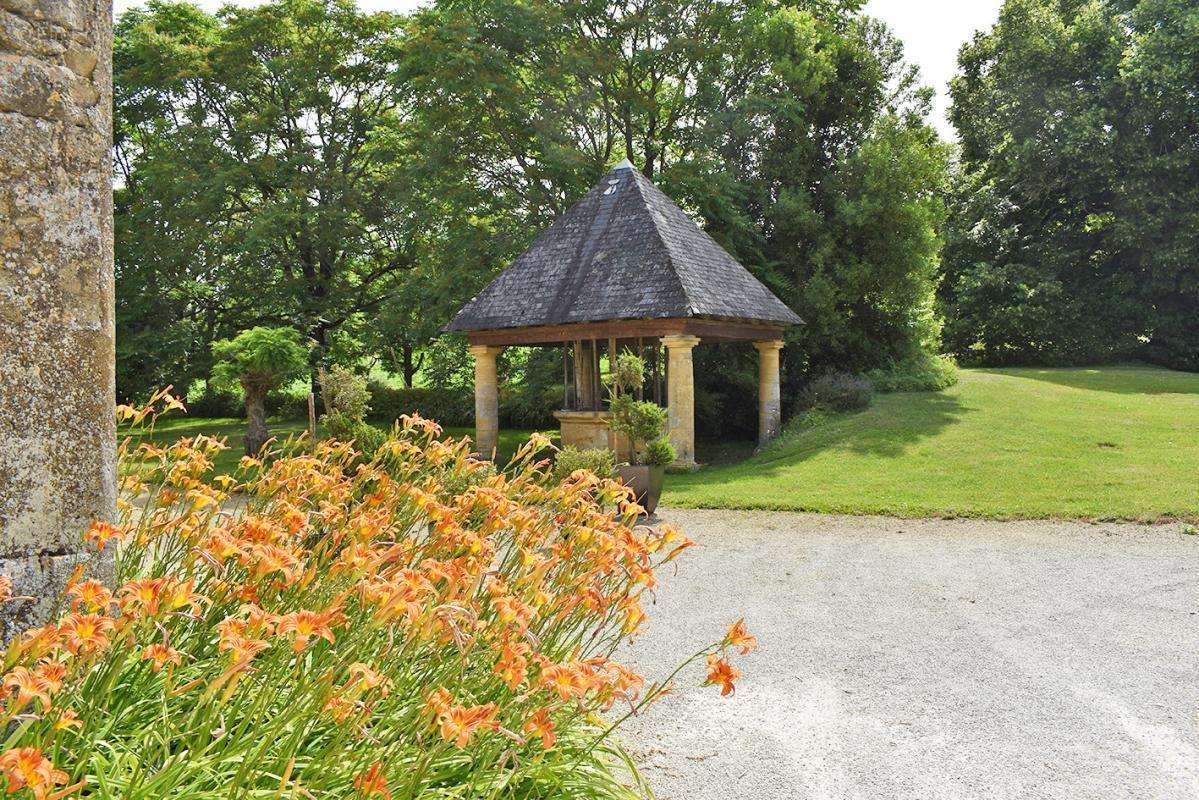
663,366 -> 1199,519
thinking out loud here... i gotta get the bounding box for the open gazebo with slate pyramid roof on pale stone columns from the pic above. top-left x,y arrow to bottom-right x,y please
446,161 -> 801,468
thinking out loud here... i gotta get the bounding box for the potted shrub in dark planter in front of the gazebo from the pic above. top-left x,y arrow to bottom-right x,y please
608,353 -> 675,513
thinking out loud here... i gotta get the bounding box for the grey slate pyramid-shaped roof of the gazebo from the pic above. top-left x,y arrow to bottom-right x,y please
446,161 -> 801,331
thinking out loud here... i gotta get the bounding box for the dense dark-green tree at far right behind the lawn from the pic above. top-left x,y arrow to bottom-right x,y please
940,0 -> 1199,366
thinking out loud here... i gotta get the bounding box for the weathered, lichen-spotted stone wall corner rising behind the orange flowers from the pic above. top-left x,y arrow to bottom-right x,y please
0,0 -> 116,636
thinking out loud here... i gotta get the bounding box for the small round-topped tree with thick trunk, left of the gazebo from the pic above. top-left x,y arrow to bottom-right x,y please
212,326 -> 308,456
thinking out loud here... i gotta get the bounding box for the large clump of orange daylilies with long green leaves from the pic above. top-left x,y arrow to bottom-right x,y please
0,393 -> 757,800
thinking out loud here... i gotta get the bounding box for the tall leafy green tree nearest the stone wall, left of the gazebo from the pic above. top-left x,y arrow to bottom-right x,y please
114,0 -> 415,393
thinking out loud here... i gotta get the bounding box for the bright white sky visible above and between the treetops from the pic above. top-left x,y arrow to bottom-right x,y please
115,0 -> 1002,139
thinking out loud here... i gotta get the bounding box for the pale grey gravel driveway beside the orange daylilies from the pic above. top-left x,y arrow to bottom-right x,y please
623,511 -> 1199,800
